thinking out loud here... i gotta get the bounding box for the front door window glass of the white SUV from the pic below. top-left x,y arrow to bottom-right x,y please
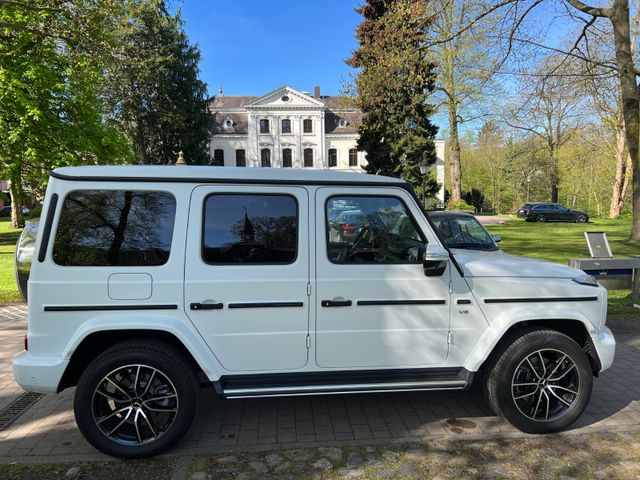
326,196 -> 425,264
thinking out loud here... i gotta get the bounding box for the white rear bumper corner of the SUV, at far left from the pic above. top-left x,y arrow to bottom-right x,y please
13,352 -> 69,393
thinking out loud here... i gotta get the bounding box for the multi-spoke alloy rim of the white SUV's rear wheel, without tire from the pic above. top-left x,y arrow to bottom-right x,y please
92,364 -> 178,446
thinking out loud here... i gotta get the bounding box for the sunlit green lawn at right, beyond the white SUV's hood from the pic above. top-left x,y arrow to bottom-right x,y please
487,218 -> 640,318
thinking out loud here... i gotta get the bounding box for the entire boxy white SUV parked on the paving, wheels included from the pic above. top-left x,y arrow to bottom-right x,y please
14,166 -> 615,458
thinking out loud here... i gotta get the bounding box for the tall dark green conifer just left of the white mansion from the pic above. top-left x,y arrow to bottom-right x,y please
107,0 -> 211,164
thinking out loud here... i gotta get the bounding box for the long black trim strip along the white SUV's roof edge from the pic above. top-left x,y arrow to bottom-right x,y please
49,170 -> 411,190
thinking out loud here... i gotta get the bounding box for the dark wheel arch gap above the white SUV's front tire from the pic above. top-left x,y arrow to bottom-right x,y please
476,319 -> 602,376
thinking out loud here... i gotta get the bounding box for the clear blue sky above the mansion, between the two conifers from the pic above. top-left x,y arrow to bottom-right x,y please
177,0 -> 362,95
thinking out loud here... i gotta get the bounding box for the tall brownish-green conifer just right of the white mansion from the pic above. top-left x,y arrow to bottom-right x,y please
347,0 -> 437,198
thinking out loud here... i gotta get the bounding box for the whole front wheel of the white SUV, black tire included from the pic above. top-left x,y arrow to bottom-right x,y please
483,329 -> 593,433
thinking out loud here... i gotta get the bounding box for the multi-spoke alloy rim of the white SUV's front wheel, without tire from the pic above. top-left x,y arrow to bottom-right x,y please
511,349 -> 580,422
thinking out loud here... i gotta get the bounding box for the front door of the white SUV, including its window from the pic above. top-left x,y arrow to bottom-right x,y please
315,188 -> 451,368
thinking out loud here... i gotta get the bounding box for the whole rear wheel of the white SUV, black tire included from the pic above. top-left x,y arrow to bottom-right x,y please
74,340 -> 200,458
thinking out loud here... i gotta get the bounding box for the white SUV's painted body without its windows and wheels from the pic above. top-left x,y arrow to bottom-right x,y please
14,166 -> 615,458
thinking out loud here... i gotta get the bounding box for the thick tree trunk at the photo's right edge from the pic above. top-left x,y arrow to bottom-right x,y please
609,0 -> 640,242
